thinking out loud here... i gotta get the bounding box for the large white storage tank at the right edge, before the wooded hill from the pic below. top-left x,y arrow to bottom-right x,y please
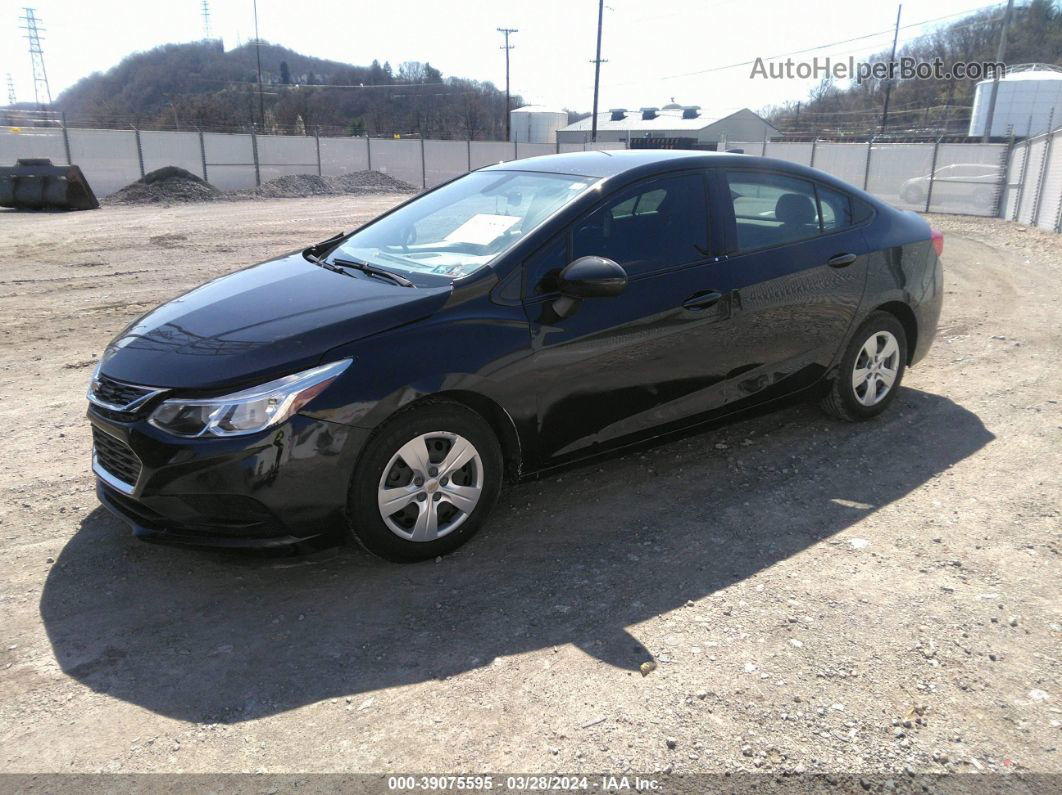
969,64 -> 1062,137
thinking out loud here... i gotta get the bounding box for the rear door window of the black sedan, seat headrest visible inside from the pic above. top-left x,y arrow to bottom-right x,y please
726,171 -> 820,252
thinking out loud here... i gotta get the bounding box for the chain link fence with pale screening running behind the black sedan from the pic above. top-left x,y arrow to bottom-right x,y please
0,126 -> 1062,232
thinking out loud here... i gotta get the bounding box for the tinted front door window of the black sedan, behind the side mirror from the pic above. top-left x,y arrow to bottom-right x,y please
571,174 -> 708,276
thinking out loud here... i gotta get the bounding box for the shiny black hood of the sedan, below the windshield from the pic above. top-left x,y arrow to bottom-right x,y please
101,253 -> 451,391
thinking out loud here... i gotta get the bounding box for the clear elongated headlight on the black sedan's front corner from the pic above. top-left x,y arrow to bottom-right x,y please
148,359 -> 352,438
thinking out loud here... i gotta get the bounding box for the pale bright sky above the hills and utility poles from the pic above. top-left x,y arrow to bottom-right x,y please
0,0 -> 1004,116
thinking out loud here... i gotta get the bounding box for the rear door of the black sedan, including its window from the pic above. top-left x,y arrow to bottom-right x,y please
715,169 -> 869,407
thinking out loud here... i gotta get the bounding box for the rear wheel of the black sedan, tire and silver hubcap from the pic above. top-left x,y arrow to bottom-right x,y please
822,312 -> 907,422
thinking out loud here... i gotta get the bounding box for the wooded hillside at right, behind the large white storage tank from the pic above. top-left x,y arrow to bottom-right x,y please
765,0 -> 1062,135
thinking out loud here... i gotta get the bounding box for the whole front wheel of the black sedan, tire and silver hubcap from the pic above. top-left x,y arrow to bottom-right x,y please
347,403 -> 503,561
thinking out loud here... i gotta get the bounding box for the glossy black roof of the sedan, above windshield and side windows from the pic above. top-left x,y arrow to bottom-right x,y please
480,149 -> 885,207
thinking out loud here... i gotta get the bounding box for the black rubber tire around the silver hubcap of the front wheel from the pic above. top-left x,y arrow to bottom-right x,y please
347,401 -> 504,563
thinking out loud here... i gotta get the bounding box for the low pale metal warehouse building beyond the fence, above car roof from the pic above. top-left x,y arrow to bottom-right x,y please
556,102 -> 780,143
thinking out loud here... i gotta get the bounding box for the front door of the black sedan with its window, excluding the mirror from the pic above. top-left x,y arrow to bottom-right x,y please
525,171 -> 730,466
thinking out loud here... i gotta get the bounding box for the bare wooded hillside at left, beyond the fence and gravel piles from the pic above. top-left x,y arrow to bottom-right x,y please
55,41 -> 518,138
